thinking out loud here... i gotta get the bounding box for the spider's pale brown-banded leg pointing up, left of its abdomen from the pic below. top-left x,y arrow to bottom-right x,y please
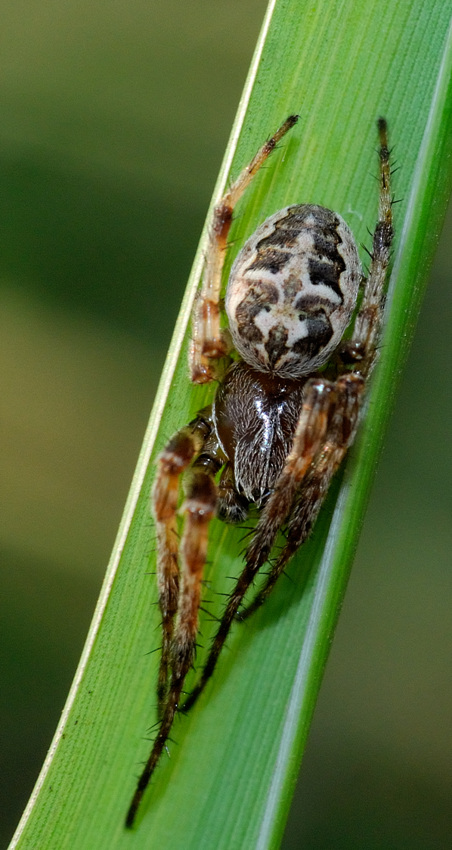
189,115 -> 298,384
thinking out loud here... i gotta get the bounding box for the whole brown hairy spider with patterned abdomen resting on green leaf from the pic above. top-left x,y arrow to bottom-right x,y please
126,115 -> 393,827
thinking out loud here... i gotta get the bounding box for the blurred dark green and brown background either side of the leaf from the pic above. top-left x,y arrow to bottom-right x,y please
0,0 -> 452,850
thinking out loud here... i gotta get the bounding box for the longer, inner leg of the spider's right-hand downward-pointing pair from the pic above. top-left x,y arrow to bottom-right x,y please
181,379 -> 334,711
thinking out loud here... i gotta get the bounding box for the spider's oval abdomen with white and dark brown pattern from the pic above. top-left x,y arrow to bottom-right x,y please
226,204 -> 362,378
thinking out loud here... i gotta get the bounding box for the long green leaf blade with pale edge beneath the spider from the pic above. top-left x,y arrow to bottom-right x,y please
12,0 -> 452,850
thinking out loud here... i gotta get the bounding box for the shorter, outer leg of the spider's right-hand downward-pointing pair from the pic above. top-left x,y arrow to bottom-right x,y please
237,373 -> 364,620
